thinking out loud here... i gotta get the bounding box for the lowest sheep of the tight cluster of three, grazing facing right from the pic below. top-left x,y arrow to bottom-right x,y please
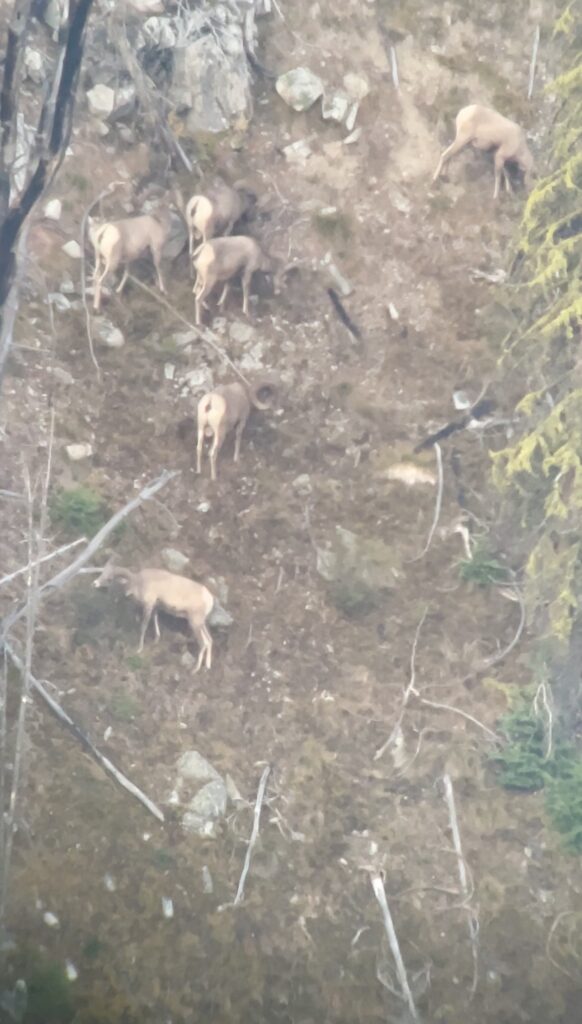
193,234 -> 287,326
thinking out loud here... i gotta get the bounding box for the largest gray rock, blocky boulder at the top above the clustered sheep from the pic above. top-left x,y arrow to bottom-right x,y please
168,22 -> 252,133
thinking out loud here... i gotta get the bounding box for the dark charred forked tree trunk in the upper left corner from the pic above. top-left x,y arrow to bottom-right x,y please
0,0 -> 93,381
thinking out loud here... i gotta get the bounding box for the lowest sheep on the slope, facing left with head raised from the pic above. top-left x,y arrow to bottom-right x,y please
93,563 -> 214,672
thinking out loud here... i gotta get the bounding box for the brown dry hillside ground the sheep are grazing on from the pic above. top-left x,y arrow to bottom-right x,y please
0,0 -> 582,1024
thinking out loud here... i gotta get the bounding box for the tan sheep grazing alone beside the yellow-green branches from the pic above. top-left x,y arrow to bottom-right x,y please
432,103 -> 534,199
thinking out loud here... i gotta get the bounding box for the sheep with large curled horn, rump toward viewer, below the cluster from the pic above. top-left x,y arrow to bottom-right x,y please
196,381 -> 271,480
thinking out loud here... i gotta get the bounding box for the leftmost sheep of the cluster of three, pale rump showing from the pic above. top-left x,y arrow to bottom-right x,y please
89,208 -> 172,312
